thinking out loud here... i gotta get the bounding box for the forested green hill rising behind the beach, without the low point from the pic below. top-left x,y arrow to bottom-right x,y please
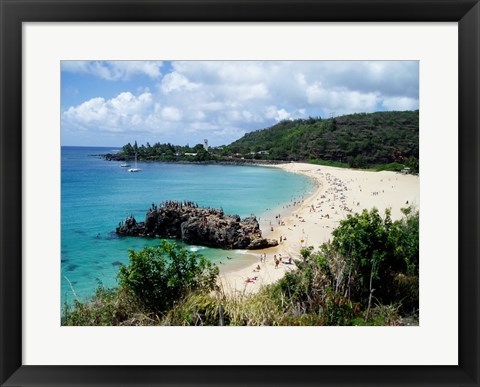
228,110 -> 419,168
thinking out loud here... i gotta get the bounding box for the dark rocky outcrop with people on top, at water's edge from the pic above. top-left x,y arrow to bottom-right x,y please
116,202 -> 278,249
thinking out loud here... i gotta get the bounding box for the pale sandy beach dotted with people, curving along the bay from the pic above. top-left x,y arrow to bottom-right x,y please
220,163 -> 420,295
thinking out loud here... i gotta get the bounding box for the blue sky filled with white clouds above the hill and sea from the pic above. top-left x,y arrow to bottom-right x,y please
61,61 -> 419,147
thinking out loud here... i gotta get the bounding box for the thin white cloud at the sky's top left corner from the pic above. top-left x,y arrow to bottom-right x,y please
61,60 -> 162,81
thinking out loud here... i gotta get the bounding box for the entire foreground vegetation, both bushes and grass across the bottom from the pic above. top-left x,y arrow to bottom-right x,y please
63,208 -> 419,326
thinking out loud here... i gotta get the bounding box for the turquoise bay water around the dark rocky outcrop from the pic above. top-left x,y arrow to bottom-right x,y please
61,147 -> 314,304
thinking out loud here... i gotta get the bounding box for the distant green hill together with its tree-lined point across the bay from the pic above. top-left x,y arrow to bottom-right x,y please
105,110 -> 419,173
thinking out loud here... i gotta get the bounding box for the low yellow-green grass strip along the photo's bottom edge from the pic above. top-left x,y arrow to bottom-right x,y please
62,284 -> 412,326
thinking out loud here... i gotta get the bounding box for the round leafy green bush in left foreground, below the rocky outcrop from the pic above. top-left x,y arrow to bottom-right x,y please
118,241 -> 219,314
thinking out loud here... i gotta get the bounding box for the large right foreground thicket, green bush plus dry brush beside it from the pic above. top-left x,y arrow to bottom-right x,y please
260,208 -> 419,325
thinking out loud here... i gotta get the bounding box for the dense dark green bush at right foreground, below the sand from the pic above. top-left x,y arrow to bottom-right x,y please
332,208 -> 419,314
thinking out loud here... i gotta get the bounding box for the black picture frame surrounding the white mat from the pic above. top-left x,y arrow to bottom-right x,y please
0,0 -> 480,386
